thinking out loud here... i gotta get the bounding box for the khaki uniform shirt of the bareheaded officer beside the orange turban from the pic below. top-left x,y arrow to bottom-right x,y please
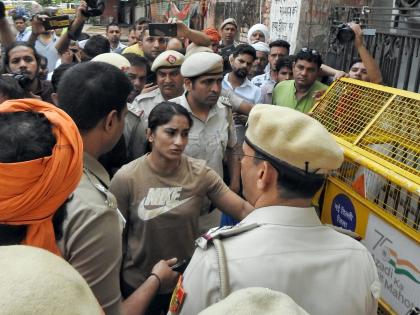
58,152 -> 124,315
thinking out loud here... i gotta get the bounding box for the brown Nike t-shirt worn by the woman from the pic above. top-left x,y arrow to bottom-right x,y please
110,155 -> 229,288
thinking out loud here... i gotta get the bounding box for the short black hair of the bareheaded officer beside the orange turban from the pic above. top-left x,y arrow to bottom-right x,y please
57,62 -> 133,132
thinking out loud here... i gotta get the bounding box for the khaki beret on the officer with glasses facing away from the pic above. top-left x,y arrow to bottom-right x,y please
245,104 -> 344,174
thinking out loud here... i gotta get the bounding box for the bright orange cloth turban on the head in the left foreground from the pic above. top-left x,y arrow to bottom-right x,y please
0,99 -> 83,255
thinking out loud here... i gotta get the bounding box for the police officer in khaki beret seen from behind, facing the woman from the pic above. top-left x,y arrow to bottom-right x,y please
171,105 -> 380,315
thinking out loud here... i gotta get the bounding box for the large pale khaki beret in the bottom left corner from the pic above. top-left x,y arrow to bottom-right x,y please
0,245 -> 102,315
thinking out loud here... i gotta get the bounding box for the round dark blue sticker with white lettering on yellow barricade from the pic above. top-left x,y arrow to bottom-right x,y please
331,194 -> 356,232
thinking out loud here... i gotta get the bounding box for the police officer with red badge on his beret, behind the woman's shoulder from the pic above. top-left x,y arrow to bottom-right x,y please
124,50 -> 185,161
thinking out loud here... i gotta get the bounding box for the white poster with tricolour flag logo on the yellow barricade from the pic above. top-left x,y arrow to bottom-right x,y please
363,214 -> 420,314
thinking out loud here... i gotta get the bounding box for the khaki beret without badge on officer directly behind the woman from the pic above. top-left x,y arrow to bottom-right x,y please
181,52 -> 223,78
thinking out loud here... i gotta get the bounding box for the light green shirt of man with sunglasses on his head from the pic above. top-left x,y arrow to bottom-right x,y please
273,80 -> 328,113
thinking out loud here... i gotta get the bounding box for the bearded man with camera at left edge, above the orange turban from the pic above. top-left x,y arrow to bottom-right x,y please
3,42 -> 53,103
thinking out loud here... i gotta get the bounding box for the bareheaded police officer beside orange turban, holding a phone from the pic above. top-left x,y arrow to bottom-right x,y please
58,62 -> 177,315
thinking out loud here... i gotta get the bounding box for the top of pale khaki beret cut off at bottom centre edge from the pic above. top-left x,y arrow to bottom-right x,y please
199,288 -> 309,315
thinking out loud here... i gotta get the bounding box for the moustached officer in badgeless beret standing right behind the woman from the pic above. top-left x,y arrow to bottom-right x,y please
171,52 -> 239,231
